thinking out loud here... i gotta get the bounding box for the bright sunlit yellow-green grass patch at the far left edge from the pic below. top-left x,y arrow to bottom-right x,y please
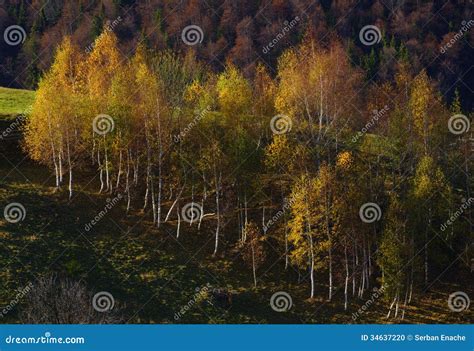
0,87 -> 35,118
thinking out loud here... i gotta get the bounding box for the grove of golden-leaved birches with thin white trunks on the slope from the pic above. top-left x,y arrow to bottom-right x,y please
23,31 -> 473,318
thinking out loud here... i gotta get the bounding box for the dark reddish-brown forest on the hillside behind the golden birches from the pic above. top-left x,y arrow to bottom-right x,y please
0,0 -> 474,109
